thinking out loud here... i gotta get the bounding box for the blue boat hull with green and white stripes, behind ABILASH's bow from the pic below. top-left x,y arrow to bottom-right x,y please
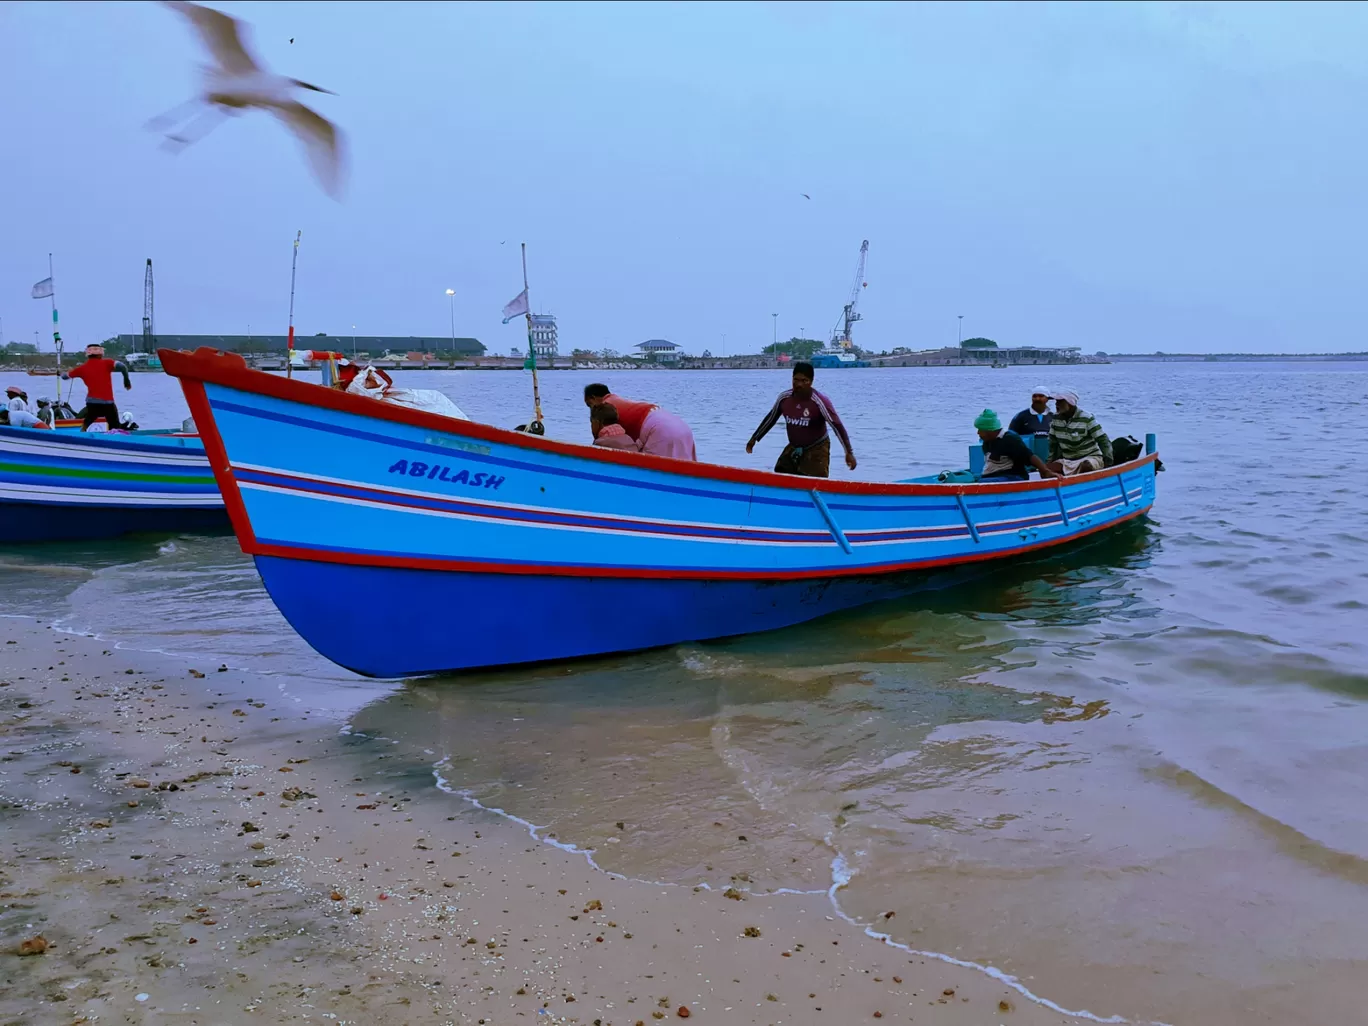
0,425 -> 228,544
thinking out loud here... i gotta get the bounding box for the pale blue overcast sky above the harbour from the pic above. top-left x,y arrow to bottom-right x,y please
0,1 -> 1368,353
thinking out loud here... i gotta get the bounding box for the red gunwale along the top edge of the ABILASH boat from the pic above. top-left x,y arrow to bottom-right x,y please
165,346 -> 1159,497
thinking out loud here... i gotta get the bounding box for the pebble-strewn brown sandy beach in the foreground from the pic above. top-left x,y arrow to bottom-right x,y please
0,618 -> 1079,1026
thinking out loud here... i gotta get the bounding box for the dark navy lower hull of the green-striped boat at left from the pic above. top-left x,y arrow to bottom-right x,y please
0,502 -> 233,544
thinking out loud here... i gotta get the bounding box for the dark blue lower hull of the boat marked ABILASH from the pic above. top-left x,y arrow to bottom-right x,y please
254,510 -> 1141,677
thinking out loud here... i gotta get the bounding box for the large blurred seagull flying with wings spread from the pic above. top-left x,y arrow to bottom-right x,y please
148,0 -> 342,198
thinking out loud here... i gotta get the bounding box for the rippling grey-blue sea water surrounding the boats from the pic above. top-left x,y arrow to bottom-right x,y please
0,364 -> 1368,1023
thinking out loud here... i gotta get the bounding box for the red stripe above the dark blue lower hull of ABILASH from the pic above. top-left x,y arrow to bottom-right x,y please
248,503 -> 1153,581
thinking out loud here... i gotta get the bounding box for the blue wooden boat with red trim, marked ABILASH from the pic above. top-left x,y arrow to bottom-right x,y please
160,349 -> 1156,677
